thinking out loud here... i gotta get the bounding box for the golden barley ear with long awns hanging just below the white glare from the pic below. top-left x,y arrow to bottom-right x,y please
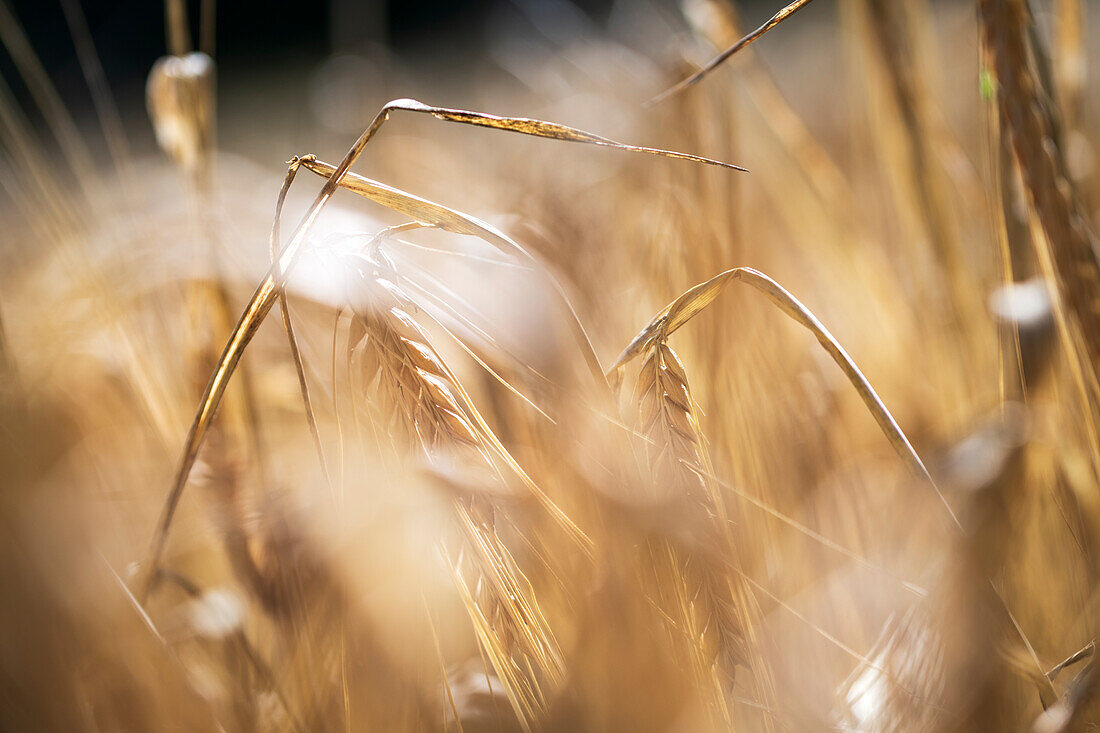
349,246 -> 564,727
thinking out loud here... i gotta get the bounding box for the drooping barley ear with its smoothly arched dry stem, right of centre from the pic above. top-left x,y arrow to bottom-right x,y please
609,267 -> 960,719
